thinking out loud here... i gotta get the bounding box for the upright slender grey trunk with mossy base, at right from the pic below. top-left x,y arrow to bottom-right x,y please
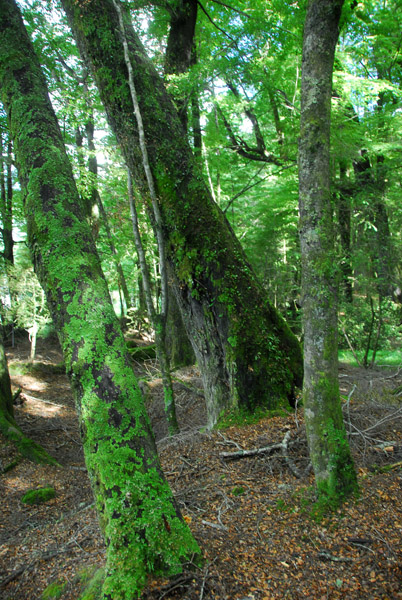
299,0 -> 357,504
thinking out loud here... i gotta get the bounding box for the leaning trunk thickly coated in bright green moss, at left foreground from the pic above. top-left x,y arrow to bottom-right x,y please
0,0 -> 197,600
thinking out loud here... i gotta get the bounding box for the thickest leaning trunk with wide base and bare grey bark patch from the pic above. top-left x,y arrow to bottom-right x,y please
63,0 -> 302,425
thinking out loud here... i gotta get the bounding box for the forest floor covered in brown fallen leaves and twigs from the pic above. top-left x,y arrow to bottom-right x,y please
0,340 -> 402,600
